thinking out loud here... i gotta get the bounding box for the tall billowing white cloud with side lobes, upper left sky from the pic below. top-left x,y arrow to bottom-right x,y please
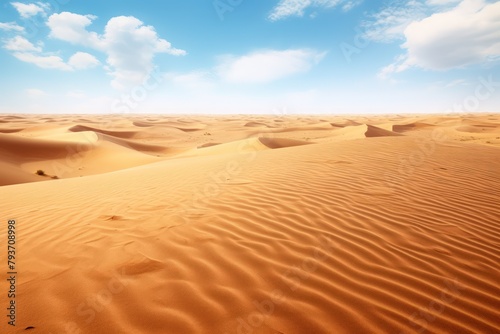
47,12 -> 186,90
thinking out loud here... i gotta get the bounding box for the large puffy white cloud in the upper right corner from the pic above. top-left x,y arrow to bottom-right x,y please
382,0 -> 500,75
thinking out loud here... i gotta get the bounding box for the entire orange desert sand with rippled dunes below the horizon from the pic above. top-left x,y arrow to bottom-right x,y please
0,114 -> 500,334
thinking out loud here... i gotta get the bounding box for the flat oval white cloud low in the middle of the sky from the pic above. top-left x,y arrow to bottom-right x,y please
217,49 -> 326,83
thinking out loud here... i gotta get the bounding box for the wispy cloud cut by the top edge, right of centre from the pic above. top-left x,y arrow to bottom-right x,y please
268,0 -> 362,21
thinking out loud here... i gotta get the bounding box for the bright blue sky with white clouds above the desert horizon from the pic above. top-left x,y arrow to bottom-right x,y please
0,0 -> 500,115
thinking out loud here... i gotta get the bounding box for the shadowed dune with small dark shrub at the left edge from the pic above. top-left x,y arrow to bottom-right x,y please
0,130 -> 180,185
